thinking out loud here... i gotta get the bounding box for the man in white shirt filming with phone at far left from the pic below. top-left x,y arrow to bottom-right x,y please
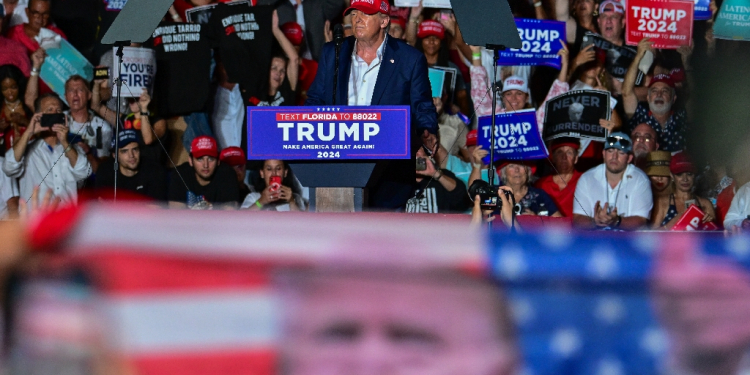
3,93 -> 91,206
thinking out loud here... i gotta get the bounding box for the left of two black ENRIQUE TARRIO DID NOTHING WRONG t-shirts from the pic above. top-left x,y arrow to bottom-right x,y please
145,22 -> 211,116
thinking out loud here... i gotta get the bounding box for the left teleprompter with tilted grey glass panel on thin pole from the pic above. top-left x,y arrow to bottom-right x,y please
102,0 -> 173,202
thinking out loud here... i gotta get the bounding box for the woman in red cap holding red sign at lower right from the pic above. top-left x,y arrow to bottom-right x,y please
653,152 -> 716,230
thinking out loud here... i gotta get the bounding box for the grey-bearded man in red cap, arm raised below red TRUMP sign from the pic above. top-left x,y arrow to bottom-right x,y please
622,38 -> 687,152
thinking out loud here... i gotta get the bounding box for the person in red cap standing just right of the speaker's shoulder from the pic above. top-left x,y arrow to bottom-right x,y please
416,20 -> 473,115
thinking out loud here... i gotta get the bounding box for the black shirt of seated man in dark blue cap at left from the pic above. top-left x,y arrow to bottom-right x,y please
96,158 -> 167,201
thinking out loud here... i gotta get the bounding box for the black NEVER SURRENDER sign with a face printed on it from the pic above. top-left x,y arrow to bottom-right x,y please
544,90 -> 611,141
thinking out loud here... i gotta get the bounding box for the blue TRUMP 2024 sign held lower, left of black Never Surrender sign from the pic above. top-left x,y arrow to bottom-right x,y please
477,109 -> 547,163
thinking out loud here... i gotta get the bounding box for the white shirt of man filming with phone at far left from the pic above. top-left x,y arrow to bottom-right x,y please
3,139 -> 91,202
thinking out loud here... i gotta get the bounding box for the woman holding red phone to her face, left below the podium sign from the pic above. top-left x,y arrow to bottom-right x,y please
242,159 -> 307,211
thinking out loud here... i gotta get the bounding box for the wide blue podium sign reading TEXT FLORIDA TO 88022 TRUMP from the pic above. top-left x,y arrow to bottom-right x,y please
247,106 -> 411,160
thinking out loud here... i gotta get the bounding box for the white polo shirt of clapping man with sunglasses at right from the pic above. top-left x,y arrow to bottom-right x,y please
573,164 -> 654,219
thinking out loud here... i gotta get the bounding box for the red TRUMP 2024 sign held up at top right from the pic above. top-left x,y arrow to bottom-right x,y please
627,0 -> 695,49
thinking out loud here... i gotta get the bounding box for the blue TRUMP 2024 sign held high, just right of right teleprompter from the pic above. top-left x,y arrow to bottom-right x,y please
497,18 -> 565,69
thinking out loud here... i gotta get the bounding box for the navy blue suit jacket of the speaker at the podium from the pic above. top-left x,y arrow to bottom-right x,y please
305,36 -> 438,138
